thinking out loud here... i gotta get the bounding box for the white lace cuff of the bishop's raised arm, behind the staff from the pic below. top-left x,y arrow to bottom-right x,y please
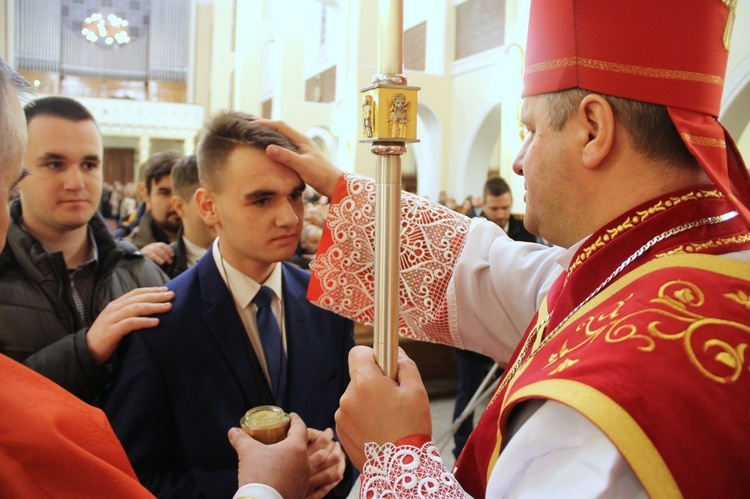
310,174 -> 470,346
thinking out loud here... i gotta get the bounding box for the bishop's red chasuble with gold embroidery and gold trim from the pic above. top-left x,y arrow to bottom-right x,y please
456,190 -> 750,498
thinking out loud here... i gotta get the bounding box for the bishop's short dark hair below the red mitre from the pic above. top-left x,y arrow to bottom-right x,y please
544,88 -> 700,168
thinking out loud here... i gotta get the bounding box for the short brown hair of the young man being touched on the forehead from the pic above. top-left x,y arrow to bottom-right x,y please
198,111 -> 297,190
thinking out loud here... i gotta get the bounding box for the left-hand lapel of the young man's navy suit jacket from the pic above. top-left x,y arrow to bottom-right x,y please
196,256 -> 273,403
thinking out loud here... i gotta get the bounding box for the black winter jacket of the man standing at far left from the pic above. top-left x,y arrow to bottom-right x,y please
0,201 -> 168,402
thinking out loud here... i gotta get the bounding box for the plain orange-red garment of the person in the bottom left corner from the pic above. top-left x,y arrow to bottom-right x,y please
0,355 -> 153,499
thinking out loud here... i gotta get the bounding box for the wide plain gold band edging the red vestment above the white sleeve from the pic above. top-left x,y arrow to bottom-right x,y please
508,379 -> 682,498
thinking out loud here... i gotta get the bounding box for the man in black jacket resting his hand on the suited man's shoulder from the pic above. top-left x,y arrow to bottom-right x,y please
0,97 -> 173,402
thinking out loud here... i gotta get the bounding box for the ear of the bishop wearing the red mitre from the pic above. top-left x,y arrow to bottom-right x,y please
578,94 -> 615,168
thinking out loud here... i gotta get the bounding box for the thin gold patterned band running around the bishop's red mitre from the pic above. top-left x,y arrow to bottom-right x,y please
524,56 -> 724,86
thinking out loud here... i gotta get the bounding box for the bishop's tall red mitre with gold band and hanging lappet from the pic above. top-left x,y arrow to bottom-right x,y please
523,0 -> 750,227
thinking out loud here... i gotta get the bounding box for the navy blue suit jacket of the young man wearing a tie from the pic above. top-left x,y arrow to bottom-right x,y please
102,251 -> 354,498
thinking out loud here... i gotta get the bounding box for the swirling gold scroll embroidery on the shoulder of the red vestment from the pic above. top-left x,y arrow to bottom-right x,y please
545,280 -> 750,384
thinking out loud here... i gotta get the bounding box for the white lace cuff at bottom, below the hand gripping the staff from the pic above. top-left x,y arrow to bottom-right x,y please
359,442 -> 470,499
